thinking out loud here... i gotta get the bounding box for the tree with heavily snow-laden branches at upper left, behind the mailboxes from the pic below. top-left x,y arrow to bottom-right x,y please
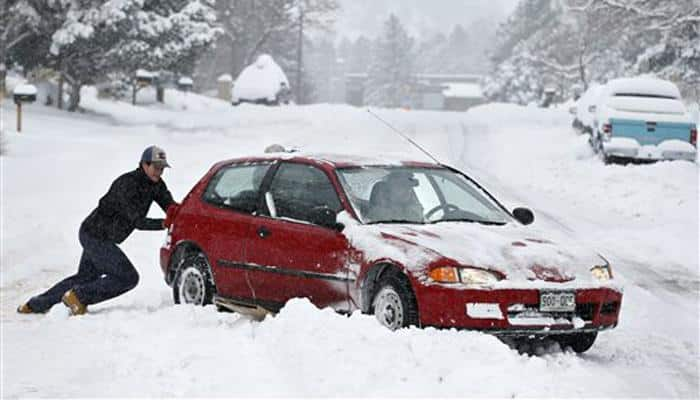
50,0 -> 218,109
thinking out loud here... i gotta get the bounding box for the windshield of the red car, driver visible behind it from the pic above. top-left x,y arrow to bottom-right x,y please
338,166 -> 510,225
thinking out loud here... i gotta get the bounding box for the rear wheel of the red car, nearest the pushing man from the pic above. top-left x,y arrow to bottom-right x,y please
173,253 -> 216,306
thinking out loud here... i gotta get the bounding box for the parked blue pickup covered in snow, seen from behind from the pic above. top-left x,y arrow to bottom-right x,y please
591,77 -> 697,162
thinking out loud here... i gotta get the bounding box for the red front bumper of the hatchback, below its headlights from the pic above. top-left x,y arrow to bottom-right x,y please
416,285 -> 622,336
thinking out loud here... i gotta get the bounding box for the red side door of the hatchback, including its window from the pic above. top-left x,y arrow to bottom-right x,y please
247,162 -> 356,310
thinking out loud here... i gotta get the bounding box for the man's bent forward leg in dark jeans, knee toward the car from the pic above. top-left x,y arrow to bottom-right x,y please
72,233 -> 139,305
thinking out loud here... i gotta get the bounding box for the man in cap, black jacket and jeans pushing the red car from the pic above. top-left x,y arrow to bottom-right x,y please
17,146 -> 176,315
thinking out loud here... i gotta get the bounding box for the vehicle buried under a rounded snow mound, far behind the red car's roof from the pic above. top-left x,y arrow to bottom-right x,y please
232,54 -> 291,105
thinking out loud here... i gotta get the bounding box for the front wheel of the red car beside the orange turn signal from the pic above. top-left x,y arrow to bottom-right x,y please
372,270 -> 418,330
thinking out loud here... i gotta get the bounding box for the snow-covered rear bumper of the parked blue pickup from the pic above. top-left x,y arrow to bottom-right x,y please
603,137 -> 697,161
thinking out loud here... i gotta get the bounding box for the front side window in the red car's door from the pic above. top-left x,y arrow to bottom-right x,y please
270,163 -> 342,222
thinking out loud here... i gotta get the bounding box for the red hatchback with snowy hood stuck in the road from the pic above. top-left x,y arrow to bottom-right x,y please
160,153 -> 622,352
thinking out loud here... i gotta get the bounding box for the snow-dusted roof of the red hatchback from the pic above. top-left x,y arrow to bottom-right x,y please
216,151 -> 441,168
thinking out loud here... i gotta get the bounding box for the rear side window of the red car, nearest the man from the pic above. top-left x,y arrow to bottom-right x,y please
203,164 -> 270,214
